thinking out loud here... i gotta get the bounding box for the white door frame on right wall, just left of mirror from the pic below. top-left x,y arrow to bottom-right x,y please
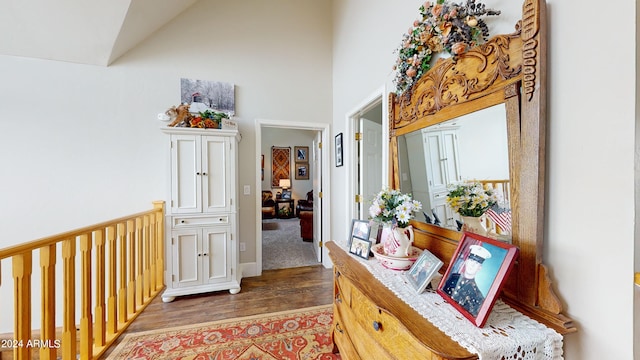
346,85 -> 389,222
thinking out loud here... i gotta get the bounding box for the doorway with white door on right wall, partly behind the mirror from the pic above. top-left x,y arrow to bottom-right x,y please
348,87 -> 389,220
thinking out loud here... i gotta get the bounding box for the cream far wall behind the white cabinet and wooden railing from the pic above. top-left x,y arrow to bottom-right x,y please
0,0 -> 331,332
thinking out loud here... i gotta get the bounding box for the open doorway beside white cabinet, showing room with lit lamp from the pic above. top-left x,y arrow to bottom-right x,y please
256,120 -> 329,274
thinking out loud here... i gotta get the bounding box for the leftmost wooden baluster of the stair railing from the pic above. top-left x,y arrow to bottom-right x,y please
11,251 -> 32,360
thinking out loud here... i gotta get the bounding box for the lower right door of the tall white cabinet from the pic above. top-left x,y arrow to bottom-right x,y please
202,226 -> 232,284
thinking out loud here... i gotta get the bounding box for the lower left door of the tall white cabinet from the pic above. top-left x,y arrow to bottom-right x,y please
171,229 -> 202,287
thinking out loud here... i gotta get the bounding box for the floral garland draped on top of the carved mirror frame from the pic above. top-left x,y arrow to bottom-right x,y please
393,0 -> 500,95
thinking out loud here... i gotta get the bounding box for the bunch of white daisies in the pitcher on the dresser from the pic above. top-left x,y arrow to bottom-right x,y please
369,189 -> 422,228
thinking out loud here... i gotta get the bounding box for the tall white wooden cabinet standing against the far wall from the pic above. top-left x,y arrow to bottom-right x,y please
162,128 -> 241,302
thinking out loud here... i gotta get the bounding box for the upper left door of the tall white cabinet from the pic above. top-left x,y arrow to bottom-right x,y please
171,135 -> 202,214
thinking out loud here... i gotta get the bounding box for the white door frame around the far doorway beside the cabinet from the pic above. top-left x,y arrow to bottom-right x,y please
254,119 -> 332,276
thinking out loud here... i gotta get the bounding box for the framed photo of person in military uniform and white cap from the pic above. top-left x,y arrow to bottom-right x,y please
437,232 -> 518,327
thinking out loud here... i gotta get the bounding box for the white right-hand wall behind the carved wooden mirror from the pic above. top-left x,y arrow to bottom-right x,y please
331,0 -> 635,360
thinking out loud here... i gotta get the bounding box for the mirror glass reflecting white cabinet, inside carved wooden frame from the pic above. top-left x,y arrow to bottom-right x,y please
398,104 -> 511,240
